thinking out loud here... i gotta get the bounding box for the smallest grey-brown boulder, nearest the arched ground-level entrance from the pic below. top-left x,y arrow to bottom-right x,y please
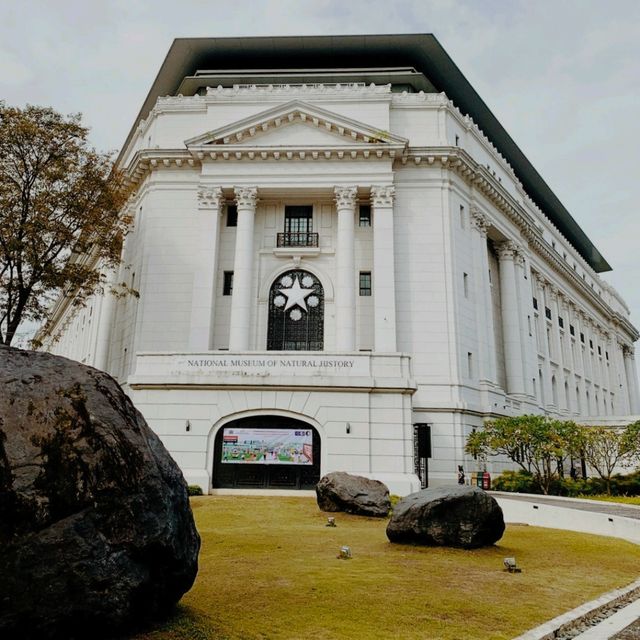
316,471 -> 391,518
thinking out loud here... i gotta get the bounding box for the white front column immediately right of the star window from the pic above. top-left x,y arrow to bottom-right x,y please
334,187 -> 360,351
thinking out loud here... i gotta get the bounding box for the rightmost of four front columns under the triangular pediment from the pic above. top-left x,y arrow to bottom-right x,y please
371,185 -> 397,353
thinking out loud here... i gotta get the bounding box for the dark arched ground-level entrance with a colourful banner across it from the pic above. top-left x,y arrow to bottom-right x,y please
212,416 -> 320,489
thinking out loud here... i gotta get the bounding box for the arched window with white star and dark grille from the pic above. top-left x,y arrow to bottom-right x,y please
267,269 -> 324,351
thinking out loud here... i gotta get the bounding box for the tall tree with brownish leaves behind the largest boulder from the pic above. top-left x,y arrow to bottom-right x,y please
0,102 -> 130,345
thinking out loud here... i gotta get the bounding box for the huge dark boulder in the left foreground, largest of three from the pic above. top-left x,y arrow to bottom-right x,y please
0,346 -> 200,640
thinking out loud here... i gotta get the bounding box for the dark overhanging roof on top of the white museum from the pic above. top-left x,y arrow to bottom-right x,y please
125,34 -> 611,272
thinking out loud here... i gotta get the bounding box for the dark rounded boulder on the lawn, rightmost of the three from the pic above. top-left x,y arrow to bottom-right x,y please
387,485 -> 504,549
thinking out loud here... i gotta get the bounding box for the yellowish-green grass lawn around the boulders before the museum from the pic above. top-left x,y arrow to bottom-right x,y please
127,496 -> 640,640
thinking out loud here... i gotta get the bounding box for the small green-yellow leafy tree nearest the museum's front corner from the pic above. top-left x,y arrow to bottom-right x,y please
465,415 -> 581,495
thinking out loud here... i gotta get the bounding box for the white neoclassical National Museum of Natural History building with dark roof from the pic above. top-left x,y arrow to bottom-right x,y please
41,35 -> 640,494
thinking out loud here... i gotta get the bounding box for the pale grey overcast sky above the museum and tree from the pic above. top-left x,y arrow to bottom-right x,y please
0,0 -> 640,344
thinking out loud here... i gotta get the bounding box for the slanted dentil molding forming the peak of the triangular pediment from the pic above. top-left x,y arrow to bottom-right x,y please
185,100 -> 408,151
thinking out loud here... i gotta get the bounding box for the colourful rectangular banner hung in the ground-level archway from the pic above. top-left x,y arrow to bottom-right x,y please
221,427 -> 313,466
